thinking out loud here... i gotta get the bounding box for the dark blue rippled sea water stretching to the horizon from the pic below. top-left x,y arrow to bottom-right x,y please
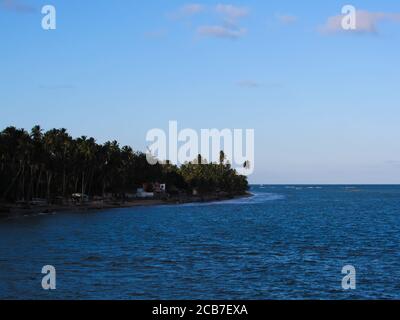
0,186 -> 400,299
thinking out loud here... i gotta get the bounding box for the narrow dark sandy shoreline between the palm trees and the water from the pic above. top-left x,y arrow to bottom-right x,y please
0,192 -> 254,219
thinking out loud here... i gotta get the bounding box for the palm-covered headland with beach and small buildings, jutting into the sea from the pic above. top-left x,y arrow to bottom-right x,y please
0,126 -> 249,215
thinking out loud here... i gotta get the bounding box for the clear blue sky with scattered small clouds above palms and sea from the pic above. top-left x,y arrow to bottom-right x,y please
0,0 -> 400,184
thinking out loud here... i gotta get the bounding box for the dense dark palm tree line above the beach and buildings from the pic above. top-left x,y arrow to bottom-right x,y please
0,126 -> 248,201
